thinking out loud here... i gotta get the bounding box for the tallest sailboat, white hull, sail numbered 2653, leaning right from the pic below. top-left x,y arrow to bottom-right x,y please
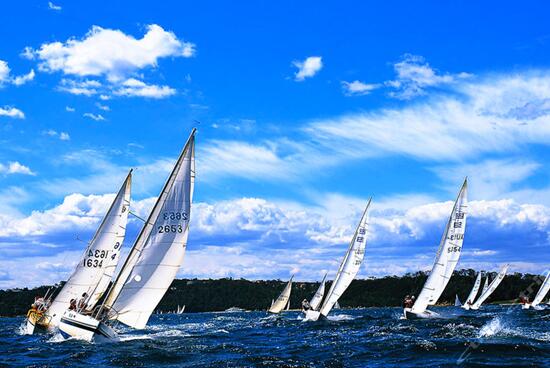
59,129 -> 196,341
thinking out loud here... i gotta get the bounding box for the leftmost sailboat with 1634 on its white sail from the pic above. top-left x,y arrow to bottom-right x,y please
26,170 -> 132,334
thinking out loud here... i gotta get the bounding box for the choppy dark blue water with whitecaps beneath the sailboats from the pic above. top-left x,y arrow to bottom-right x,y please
0,306 -> 550,368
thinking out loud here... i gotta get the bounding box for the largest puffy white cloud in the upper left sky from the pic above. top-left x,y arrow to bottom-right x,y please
29,24 -> 195,80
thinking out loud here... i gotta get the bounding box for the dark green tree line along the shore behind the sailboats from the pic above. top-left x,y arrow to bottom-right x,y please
0,269 -> 543,316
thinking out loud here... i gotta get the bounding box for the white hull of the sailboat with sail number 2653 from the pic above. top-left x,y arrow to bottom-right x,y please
59,310 -> 118,341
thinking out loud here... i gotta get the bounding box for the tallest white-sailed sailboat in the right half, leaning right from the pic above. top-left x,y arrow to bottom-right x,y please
403,179 -> 468,318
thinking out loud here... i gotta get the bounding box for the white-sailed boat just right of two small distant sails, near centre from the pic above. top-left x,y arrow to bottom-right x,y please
304,199 -> 371,321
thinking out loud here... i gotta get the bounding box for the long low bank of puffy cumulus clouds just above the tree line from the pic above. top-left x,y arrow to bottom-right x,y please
0,194 -> 550,286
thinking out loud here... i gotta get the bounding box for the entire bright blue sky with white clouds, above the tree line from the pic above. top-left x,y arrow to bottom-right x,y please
0,1 -> 550,288
